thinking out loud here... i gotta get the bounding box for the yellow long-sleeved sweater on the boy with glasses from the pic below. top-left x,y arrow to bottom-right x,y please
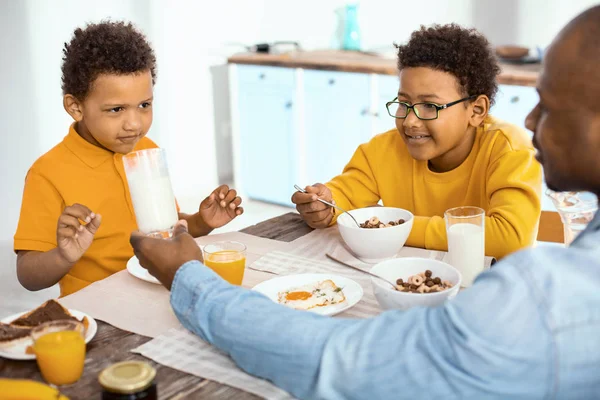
327,117 -> 542,258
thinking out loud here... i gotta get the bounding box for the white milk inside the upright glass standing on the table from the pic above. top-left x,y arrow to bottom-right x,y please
448,223 -> 485,287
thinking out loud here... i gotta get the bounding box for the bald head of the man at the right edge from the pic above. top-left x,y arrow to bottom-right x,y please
526,6 -> 600,196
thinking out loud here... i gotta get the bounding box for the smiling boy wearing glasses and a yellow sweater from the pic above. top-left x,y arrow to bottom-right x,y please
292,24 -> 542,258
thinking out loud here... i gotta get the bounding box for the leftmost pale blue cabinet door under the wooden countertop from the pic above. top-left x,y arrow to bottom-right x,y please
237,65 -> 298,205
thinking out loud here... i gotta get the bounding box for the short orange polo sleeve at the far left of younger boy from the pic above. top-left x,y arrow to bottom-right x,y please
14,168 -> 65,251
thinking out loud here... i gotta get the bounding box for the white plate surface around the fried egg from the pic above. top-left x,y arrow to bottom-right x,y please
252,274 -> 363,315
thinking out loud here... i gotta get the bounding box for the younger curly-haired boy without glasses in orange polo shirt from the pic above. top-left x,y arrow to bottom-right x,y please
14,21 -> 243,296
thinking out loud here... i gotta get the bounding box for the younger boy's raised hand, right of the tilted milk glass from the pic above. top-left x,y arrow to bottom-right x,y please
199,185 -> 244,229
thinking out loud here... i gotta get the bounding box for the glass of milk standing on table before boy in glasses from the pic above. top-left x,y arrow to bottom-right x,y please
444,207 -> 485,287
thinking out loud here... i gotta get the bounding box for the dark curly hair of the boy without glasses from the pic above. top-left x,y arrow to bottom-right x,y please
62,21 -> 156,100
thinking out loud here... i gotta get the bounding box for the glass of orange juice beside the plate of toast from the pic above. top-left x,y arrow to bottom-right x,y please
31,320 -> 85,386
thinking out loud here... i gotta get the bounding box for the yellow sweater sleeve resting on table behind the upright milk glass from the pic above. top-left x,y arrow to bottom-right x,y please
406,149 -> 542,258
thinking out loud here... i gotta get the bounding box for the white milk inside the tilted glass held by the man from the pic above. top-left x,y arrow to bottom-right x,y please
127,173 -> 178,234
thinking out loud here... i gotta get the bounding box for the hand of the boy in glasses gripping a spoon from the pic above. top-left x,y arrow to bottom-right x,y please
292,183 -> 333,229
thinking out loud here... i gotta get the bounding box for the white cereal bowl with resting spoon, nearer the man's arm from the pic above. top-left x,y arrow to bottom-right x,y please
371,257 -> 462,310
